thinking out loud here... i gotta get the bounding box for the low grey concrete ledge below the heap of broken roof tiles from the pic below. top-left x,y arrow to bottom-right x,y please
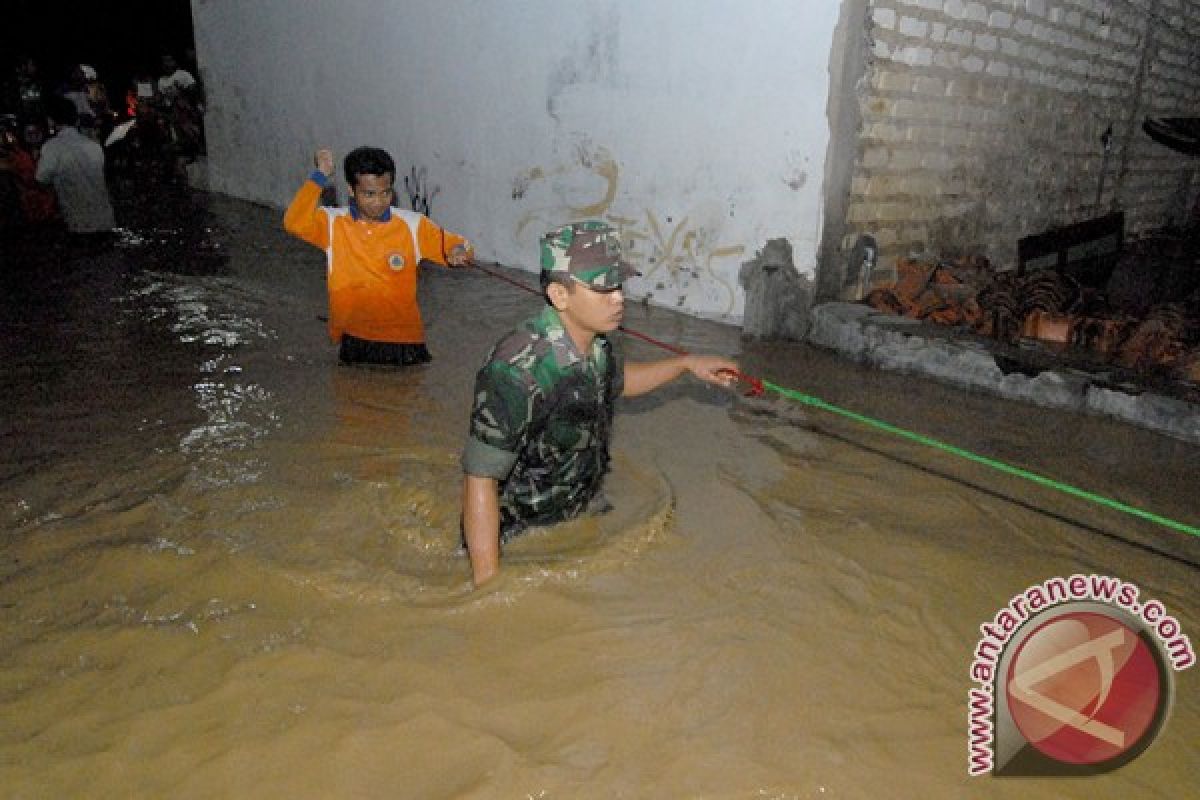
808,302 -> 1200,444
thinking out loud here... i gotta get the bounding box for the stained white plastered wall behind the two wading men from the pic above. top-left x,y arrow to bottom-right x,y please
193,0 -> 839,320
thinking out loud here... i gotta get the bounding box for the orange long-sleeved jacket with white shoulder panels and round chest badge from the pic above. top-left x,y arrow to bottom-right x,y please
283,180 -> 470,344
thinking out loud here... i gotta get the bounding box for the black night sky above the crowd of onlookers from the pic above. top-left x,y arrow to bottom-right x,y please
0,0 -> 200,100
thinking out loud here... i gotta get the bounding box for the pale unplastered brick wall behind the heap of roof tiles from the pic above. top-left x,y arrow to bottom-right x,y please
841,0 -> 1200,283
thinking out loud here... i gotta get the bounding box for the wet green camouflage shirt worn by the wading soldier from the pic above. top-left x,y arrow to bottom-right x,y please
462,306 -> 624,542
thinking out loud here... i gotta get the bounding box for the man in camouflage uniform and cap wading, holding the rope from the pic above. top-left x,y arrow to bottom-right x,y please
462,221 -> 737,585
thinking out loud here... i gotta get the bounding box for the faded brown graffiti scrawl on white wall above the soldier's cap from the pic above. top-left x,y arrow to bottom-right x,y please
512,146 -> 745,314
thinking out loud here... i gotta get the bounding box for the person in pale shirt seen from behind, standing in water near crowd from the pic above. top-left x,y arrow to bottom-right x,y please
36,97 -> 116,239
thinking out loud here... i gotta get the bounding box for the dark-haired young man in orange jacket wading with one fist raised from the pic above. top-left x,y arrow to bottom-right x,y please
283,148 -> 474,366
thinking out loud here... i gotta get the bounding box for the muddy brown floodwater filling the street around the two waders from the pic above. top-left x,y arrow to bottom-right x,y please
0,194 -> 1200,800
